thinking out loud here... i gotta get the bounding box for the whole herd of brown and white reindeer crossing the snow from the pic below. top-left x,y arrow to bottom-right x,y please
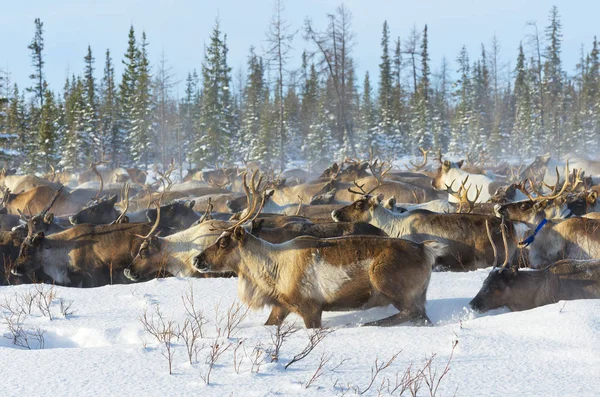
0,149 -> 600,327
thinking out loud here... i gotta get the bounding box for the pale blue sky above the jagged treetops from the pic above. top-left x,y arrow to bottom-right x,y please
0,0 -> 600,93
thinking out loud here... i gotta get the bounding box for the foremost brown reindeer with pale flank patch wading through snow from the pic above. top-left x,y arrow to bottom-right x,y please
194,181 -> 443,328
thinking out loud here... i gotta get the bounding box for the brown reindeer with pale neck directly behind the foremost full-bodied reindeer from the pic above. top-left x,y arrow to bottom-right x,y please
331,191 -> 528,271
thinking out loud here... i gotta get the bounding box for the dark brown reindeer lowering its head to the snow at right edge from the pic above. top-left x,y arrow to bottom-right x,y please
469,221 -> 600,312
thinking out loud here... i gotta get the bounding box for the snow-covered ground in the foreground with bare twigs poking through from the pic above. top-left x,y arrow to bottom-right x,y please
0,270 -> 600,396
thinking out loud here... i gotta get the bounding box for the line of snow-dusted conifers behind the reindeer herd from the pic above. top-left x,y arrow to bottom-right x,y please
0,0 -> 600,172
